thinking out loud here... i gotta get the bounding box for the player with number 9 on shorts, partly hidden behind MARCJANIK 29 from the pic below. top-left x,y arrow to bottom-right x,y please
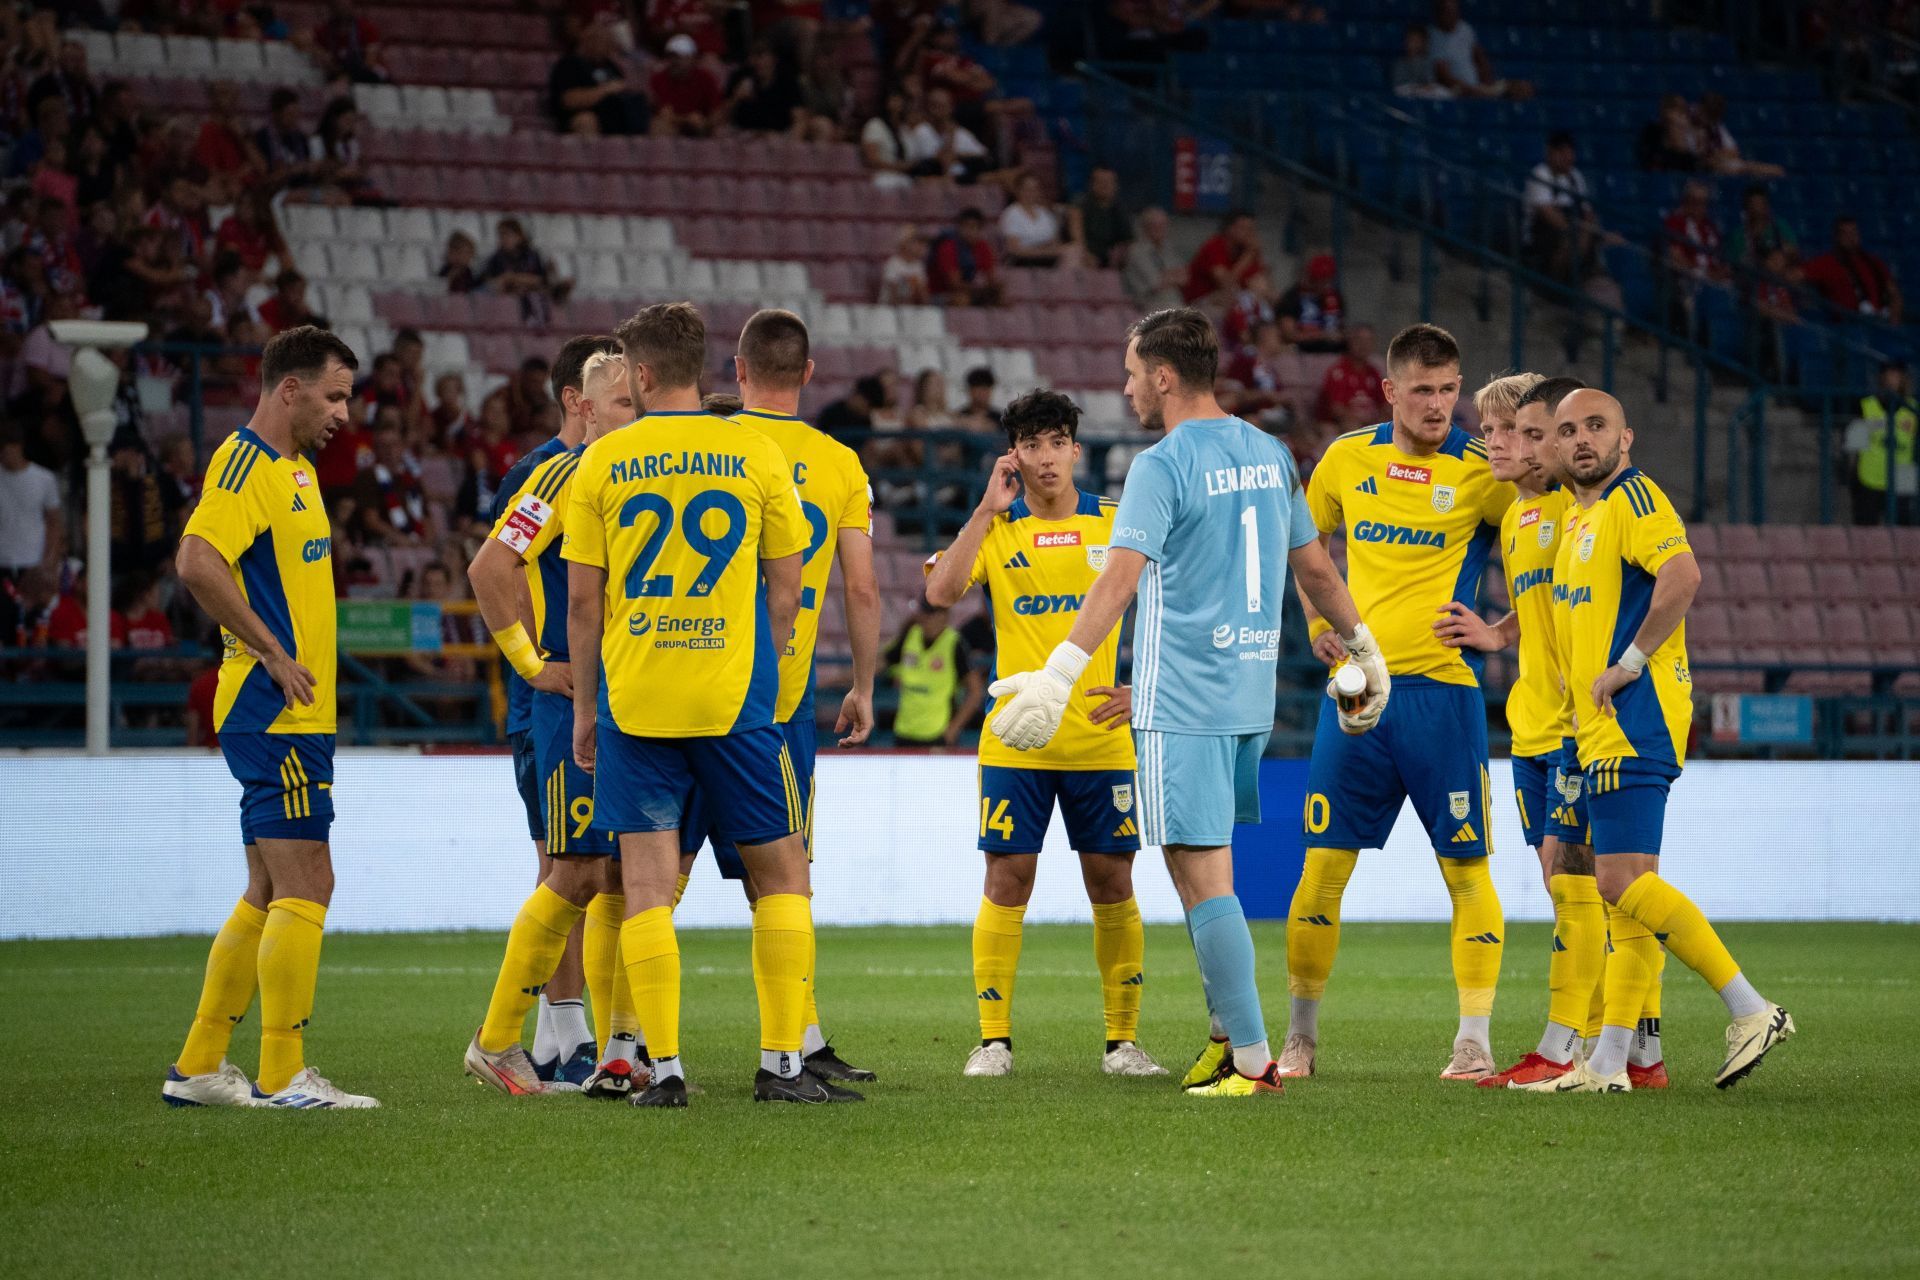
467,351 -> 645,1098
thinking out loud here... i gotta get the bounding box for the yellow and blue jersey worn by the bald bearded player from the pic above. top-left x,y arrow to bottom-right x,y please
1553,466 -> 1693,775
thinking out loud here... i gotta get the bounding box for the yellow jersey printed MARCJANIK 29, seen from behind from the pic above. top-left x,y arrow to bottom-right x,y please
561,411 -> 808,737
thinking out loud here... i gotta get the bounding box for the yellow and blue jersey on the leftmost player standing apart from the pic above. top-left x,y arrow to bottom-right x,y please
184,428 -> 338,733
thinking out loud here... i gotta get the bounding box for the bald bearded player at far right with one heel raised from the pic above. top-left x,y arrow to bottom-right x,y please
1528,390 -> 1793,1094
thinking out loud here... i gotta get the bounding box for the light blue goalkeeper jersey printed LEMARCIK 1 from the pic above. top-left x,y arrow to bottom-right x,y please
1112,418 -> 1319,735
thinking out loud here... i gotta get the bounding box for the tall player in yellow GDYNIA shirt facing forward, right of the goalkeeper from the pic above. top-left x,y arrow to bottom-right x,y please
1279,324 -> 1515,1080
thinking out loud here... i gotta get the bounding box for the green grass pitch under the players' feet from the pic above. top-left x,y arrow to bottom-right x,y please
0,925 -> 1920,1280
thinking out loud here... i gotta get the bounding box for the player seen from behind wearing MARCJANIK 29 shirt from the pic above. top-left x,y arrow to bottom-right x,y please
561,303 -> 858,1107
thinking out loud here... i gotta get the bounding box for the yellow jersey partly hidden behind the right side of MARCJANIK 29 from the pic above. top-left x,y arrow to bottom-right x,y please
733,409 -> 874,723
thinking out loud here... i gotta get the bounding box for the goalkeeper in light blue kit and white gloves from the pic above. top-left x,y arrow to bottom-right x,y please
989,307 -> 1388,1098
